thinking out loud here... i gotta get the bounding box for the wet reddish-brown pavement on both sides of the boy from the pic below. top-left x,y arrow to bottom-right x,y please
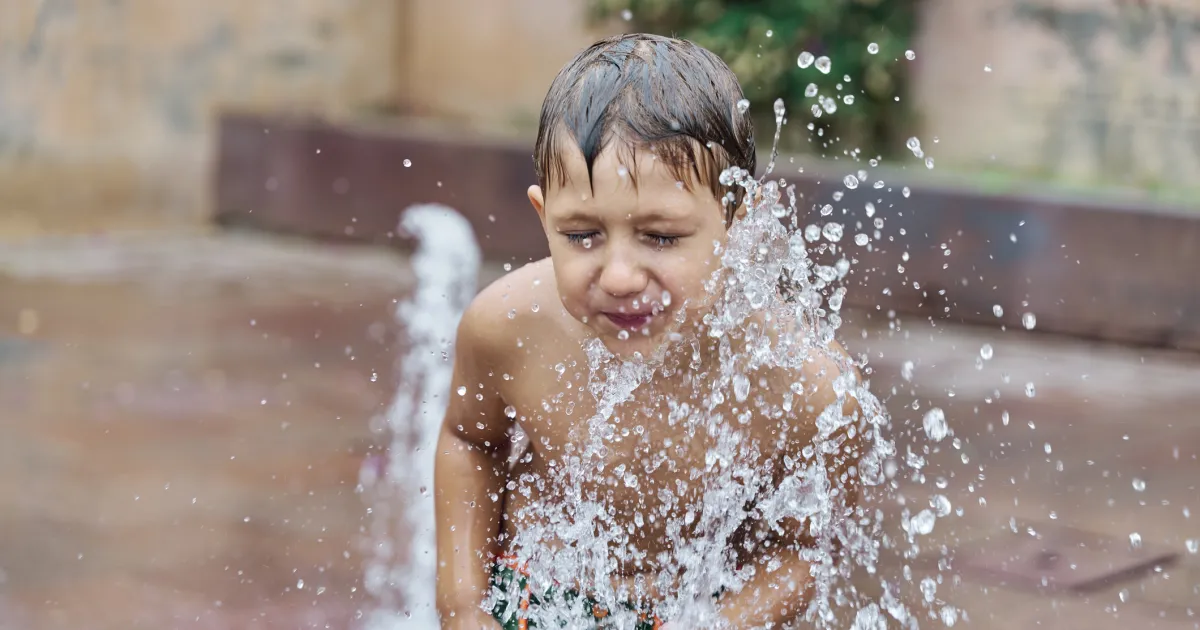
0,235 -> 1200,630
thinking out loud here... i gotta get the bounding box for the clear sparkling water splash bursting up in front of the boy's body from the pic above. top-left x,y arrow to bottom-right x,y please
472,102 -> 960,629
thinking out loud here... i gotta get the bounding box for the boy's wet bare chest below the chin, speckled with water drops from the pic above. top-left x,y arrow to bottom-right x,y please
504,348 -> 806,552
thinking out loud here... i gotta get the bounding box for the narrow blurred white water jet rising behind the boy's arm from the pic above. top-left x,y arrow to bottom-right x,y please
360,204 -> 480,630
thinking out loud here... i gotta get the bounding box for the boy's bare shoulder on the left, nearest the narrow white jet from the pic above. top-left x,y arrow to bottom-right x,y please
458,258 -> 559,356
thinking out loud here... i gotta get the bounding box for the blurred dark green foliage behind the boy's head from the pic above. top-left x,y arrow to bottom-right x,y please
589,0 -> 919,158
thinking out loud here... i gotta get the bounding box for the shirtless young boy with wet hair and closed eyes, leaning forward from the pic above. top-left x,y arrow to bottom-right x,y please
434,35 -> 856,630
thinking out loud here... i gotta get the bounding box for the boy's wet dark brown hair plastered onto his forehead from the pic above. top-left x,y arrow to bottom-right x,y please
534,34 -> 756,222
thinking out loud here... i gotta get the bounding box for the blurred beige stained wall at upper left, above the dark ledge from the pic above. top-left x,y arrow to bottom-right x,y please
0,0 -> 401,236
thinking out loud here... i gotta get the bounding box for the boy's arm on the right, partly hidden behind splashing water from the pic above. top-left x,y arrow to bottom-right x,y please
720,348 -> 863,628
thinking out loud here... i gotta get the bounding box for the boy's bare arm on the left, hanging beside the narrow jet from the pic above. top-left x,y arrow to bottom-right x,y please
433,304 -> 511,629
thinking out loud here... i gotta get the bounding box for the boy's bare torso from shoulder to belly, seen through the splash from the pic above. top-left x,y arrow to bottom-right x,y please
490,262 -> 815,575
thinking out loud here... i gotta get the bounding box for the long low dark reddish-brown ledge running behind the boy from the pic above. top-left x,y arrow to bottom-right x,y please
215,115 -> 1200,350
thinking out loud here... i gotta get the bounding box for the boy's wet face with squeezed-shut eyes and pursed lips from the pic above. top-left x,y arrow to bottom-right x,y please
529,144 -> 726,356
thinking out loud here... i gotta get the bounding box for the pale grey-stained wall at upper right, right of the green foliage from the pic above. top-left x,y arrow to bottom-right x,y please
914,0 -> 1200,187
